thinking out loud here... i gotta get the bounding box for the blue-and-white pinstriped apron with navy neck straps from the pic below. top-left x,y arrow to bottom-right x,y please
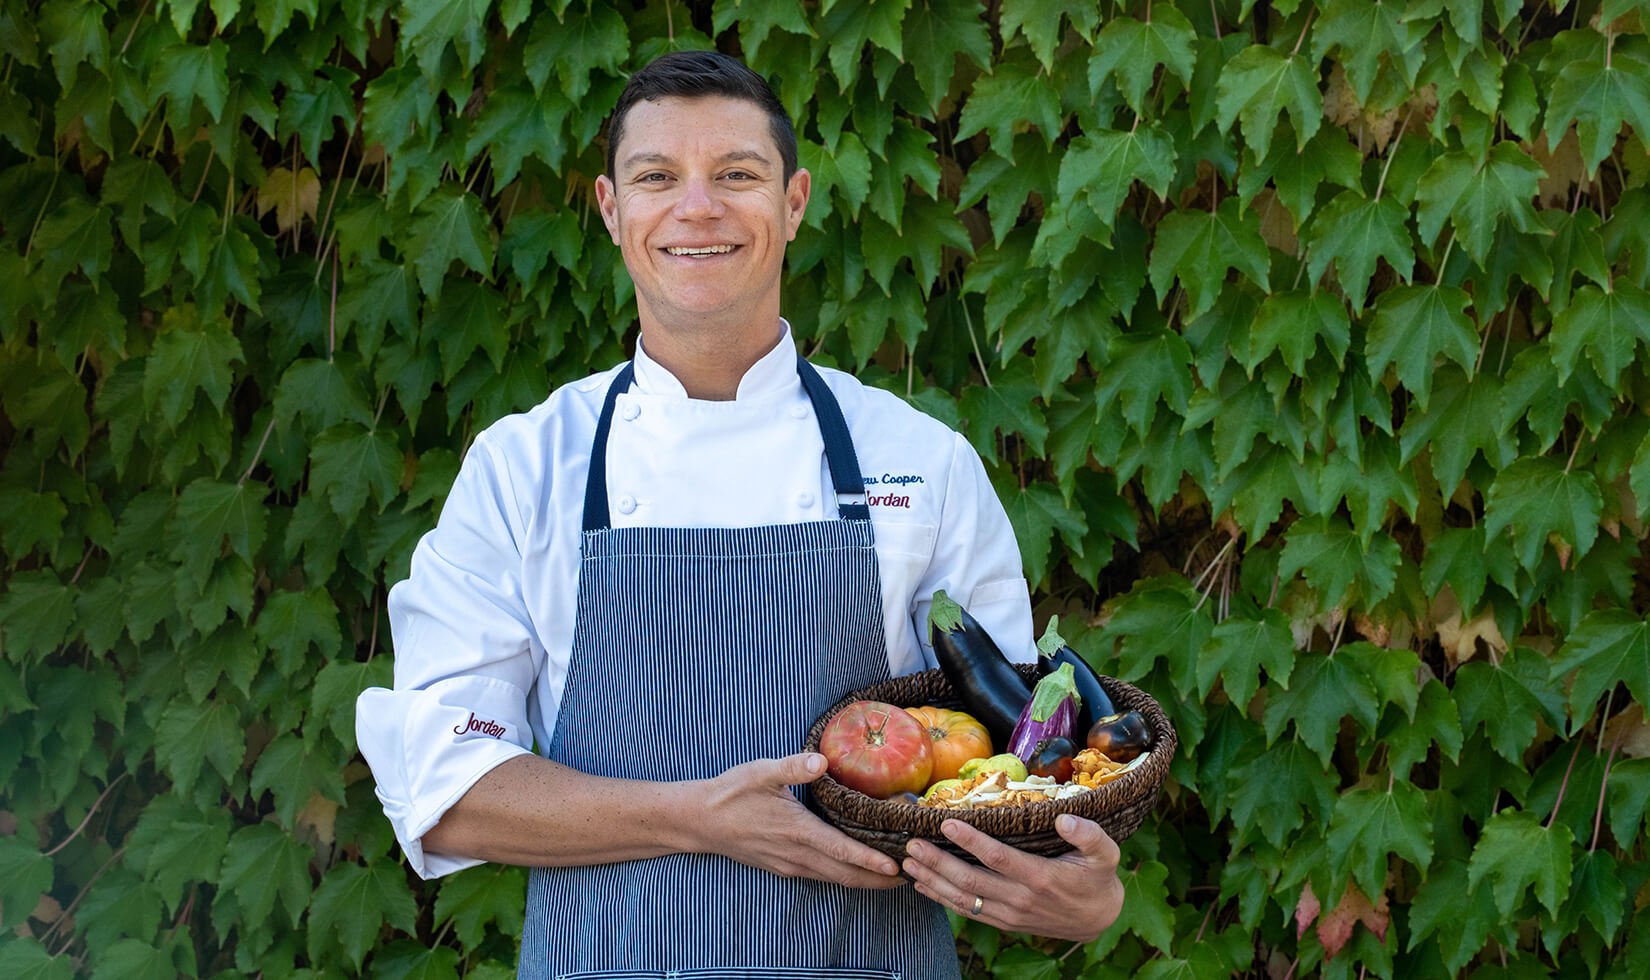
518,356 -> 959,980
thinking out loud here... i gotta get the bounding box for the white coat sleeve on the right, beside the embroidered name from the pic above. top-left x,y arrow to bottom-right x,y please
912,436 -> 1038,663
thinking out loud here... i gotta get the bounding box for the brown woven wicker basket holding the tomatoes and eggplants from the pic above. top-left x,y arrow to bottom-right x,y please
804,663 -> 1178,863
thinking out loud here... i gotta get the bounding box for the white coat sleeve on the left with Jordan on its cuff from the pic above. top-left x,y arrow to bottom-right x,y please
355,436 -> 545,878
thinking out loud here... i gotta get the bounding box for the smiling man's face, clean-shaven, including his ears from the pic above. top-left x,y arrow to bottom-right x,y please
596,96 -> 810,328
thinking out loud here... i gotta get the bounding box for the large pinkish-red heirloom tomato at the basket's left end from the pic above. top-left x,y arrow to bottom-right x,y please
820,701 -> 934,800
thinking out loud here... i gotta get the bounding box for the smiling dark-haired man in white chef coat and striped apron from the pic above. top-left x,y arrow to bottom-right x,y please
358,53 -> 1122,977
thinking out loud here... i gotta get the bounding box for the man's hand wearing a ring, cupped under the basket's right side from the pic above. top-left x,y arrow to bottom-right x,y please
904,813 -> 1124,942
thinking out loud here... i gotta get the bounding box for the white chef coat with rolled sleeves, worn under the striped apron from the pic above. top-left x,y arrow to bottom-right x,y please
356,320 -> 1036,878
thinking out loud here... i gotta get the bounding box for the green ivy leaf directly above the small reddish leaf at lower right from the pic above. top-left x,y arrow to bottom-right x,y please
1328,780 -> 1432,894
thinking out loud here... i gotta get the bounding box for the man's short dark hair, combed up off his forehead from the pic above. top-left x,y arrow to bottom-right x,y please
607,51 -> 797,183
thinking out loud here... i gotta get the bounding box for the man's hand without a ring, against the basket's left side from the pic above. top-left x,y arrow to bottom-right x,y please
695,752 -> 904,888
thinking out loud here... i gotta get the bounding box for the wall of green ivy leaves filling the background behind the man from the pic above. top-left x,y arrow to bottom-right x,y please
0,0 -> 1650,978
